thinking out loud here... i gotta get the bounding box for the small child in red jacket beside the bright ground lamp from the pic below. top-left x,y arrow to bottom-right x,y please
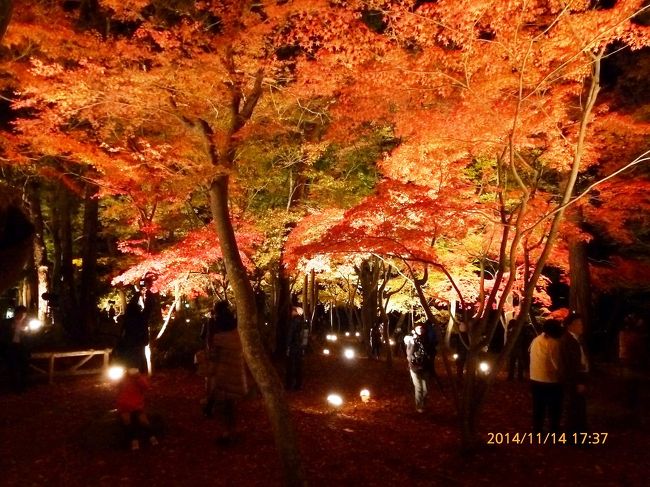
116,368 -> 158,450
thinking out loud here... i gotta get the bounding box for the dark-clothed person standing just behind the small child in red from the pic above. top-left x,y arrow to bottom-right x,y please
116,293 -> 149,372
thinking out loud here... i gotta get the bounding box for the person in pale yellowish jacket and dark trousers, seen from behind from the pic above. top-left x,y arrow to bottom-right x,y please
530,319 -> 562,433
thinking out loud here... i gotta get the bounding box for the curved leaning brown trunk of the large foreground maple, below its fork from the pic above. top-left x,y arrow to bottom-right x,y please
210,174 -> 305,486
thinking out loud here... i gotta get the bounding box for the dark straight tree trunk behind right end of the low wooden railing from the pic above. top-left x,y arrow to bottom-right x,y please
79,186 -> 99,338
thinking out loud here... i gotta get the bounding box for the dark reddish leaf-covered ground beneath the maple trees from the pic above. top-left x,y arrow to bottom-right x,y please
0,346 -> 650,486
